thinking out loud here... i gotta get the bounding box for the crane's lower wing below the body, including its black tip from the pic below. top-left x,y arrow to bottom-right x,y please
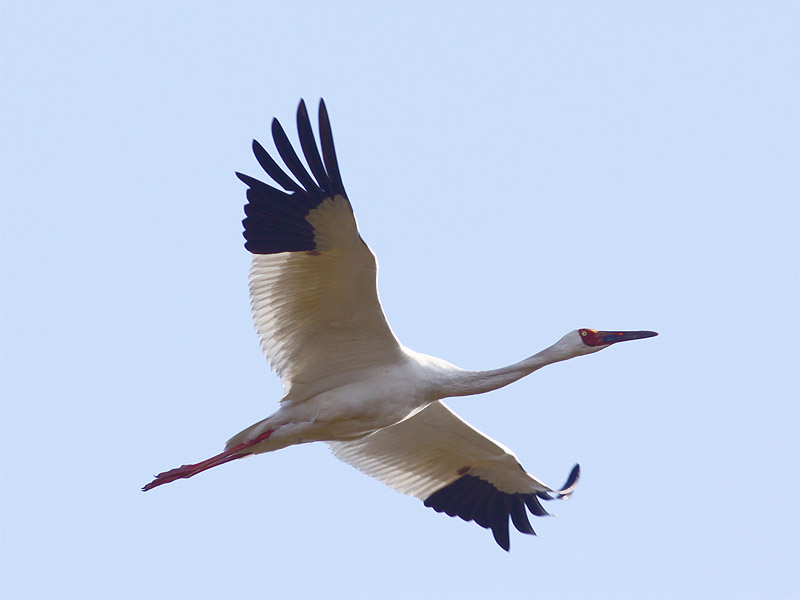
330,401 -> 580,550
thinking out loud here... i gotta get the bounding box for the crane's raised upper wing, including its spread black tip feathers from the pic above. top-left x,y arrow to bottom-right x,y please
236,100 -> 402,400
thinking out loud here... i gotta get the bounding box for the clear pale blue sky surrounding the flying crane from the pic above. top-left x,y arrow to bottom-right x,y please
0,2 -> 800,598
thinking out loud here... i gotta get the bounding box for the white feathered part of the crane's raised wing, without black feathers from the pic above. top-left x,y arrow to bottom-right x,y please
250,196 -> 403,402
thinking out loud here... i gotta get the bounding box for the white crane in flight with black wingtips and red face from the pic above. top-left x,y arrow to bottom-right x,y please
143,100 -> 657,550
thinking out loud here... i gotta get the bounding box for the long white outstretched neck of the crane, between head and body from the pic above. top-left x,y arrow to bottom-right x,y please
442,344 -> 574,398
